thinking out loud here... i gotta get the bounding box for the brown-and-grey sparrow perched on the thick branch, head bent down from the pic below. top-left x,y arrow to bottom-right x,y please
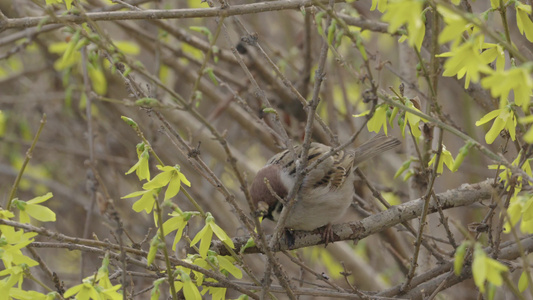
250,135 -> 400,245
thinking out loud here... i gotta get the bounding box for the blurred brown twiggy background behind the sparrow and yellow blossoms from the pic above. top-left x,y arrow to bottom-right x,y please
0,0 -> 532,299
